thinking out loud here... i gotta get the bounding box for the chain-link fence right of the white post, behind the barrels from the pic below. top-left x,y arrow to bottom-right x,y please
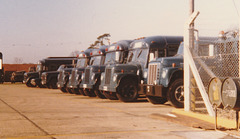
190,0 -> 240,118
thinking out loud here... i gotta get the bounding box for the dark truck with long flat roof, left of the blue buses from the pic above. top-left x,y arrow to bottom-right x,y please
23,57 -> 77,87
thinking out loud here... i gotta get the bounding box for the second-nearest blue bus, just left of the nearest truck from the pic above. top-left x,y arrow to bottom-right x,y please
99,36 -> 183,102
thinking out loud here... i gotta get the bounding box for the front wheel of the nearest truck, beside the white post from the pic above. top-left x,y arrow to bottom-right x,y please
168,79 -> 184,108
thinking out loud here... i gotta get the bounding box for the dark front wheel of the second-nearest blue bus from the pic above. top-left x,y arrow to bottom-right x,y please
117,80 -> 138,102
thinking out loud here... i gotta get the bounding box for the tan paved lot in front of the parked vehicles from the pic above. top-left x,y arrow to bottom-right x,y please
0,83 -> 238,139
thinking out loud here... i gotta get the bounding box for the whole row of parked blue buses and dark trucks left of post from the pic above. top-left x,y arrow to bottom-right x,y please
24,36 -> 218,108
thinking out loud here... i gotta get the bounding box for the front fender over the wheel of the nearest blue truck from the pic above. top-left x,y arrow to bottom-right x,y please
159,67 -> 183,87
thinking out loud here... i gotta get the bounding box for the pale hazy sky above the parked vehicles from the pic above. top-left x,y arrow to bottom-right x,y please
0,0 -> 240,64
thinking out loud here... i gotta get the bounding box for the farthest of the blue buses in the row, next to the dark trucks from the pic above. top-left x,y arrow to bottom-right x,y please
57,49 -> 92,93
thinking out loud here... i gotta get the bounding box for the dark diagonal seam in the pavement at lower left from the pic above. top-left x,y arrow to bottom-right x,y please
0,98 -> 55,139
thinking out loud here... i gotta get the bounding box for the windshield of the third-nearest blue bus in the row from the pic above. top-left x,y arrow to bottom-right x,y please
104,51 -> 121,64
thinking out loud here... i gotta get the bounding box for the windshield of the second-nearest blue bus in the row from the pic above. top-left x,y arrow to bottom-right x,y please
128,49 -> 148,66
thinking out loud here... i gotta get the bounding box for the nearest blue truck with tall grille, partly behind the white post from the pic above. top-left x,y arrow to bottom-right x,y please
142,37 -> 216,108
